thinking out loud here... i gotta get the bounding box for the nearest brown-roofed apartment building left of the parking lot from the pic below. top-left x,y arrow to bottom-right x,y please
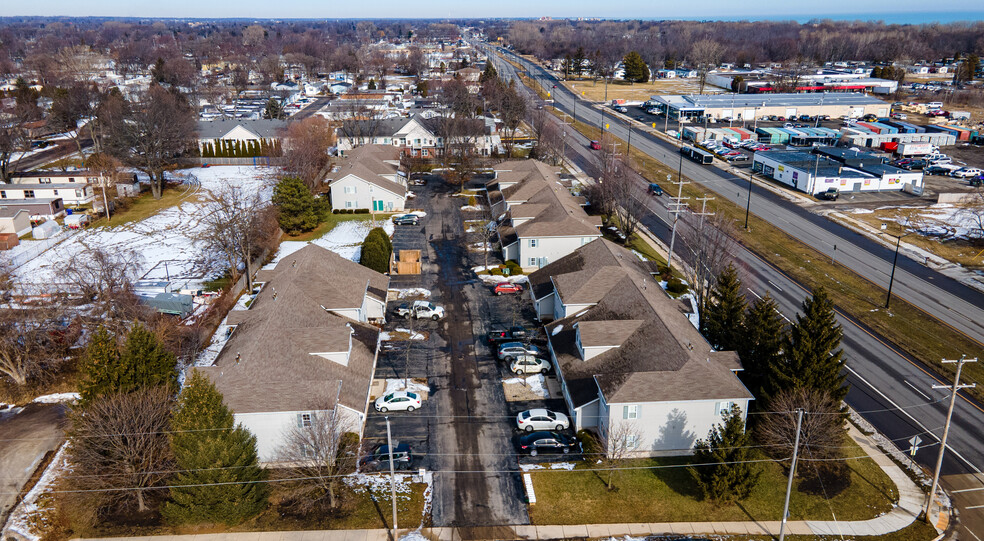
195,244 -> 389,463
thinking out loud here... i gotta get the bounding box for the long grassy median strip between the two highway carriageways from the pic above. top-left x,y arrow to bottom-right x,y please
536,77 -> 984,399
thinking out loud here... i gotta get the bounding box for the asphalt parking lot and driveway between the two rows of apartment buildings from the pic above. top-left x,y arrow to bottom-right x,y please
365,177 -> 573,526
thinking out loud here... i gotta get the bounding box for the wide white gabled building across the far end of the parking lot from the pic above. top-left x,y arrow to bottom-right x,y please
337,114 -> 503,158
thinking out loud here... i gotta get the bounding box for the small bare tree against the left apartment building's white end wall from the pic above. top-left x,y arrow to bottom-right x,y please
277,408 -> 359,510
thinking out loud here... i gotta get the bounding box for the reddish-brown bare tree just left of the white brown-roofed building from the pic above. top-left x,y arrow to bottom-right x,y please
284,115 -> 335,193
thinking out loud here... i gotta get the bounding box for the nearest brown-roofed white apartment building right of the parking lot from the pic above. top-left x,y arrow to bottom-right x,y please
530,239 -> 753,456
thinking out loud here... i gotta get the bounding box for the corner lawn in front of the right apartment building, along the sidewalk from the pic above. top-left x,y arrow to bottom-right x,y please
529,436 -> 898,524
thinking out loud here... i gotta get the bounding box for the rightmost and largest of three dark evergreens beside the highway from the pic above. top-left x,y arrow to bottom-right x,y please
775,287 -> 847,401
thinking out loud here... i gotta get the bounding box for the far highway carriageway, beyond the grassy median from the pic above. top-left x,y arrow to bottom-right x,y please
499,47 -> 984,355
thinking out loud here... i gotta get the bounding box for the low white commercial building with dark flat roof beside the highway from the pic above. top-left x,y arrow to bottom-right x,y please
752,147 -> 923,195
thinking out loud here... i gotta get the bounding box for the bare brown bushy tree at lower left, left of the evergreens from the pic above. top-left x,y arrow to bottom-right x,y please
68,387 -> 174,512
